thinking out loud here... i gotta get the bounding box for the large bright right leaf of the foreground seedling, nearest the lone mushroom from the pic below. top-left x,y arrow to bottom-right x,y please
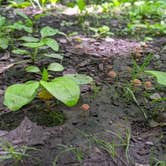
40,77 -> 80,107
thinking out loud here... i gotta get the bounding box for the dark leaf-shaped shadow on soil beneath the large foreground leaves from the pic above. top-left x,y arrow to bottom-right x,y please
0,102 -> 64,131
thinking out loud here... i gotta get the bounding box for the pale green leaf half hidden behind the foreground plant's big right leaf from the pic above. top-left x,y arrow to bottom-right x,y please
65,74 -> 93,85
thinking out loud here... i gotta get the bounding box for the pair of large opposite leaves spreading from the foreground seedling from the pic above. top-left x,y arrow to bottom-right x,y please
4,77 -> 80,111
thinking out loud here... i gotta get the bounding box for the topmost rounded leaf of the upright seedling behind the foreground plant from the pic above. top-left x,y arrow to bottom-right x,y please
40,26 -> 59,38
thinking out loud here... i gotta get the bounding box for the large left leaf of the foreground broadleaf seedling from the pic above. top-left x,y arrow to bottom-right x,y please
4,81 -> 39,111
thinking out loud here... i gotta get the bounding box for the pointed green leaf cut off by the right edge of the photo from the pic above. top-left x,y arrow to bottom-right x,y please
145,70 -> 166,86
